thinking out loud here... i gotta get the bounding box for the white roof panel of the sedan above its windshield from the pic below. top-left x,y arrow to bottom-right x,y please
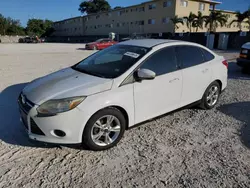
119,39 -> 179,48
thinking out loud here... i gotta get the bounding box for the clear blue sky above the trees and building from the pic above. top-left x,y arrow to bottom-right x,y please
0,0 -> 250,26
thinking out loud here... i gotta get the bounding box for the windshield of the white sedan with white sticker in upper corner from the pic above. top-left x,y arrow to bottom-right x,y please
72,45 -> 150,78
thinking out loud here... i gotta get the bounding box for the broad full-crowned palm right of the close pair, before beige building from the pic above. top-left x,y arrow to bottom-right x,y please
204,11 -> 228,32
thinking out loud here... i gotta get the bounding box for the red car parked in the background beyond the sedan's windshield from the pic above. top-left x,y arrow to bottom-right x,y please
85,39 -> 117,50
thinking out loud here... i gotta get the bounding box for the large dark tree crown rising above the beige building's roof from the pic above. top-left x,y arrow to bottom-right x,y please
78,0 -> 111,14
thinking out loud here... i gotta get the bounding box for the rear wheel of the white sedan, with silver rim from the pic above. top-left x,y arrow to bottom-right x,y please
200,81 -> 221,110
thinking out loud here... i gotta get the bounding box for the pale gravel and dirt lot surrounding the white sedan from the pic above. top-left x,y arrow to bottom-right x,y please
0,44 -> 250,188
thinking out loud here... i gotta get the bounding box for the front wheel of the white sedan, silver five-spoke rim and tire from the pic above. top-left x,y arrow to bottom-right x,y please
82,108 -> 127,151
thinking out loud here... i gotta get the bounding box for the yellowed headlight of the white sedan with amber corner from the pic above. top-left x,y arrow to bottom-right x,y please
37,97 -> 86,115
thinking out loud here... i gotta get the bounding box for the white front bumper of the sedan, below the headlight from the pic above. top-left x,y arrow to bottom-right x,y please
18,96 -> 86,144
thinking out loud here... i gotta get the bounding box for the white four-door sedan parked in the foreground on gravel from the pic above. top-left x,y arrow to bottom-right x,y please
18,39 -> 228,150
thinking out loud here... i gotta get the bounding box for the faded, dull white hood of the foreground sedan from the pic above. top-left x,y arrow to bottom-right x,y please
23,68 -> 113,104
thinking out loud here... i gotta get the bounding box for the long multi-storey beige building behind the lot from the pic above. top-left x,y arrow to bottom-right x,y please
51,0 -> 249,36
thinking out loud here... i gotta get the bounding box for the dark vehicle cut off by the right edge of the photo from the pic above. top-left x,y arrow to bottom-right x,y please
237,42 -> 250,73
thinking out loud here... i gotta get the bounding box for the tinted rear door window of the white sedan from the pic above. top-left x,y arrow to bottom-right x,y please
176,45 -> 205,69
